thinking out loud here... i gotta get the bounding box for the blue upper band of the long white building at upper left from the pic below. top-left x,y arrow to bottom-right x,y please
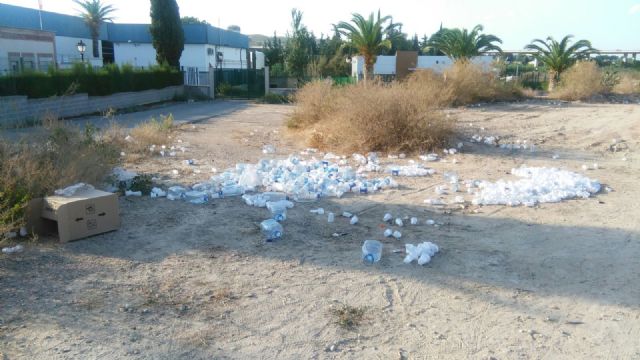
0,4 -> 249,48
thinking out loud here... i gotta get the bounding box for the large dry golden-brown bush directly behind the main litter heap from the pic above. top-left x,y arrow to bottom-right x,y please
289,74 -> 453,151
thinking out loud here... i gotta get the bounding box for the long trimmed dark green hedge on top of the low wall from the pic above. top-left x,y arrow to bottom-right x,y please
0,66 -> 183,98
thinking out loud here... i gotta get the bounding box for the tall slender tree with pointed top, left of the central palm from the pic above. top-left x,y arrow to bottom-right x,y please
285,9 -> 315,82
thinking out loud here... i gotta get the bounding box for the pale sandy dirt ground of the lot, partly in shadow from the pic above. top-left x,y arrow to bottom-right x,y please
0,101 -> 640,359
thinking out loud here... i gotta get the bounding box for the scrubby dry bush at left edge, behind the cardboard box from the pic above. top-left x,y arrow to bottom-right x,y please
0,117 -> 120,237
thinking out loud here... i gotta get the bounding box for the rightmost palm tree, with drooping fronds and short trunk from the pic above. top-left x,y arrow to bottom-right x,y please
525,35 -> 598,91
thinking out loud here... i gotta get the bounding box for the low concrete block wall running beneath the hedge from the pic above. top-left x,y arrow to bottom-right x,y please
0,86 -> 184,127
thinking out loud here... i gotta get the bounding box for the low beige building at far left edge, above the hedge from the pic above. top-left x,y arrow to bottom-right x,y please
0,27 -> 56,75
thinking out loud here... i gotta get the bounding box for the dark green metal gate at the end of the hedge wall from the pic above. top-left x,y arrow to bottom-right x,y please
214,69 -> 265,99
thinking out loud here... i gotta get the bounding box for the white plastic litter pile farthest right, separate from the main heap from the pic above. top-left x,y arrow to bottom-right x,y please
473,166 -> 600,206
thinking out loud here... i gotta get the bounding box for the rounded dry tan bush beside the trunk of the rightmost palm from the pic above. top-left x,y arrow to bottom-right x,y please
549,61 -> 606,100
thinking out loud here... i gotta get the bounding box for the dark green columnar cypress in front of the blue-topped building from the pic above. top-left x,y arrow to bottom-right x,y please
149,0 -> 184,67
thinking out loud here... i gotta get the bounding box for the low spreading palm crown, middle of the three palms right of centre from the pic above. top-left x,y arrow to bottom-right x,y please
429,25 -> 502,61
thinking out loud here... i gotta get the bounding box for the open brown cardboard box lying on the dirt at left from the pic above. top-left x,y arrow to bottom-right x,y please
27,190 -> 120,242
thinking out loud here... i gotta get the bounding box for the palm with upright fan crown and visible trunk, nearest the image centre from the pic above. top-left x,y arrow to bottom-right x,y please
335,11 -> 402,83
